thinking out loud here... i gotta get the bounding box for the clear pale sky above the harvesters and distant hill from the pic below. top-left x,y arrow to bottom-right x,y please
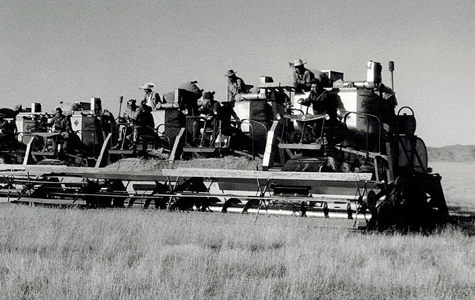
0,0 -> 475,147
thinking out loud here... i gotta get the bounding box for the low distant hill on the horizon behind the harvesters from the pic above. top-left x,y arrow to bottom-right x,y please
427,145 -> 475,162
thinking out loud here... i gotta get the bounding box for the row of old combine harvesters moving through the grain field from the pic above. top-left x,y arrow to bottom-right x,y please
0,61 -> 449,231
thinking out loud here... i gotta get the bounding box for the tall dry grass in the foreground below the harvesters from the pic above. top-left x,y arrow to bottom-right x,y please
0,205 -> 475,299
